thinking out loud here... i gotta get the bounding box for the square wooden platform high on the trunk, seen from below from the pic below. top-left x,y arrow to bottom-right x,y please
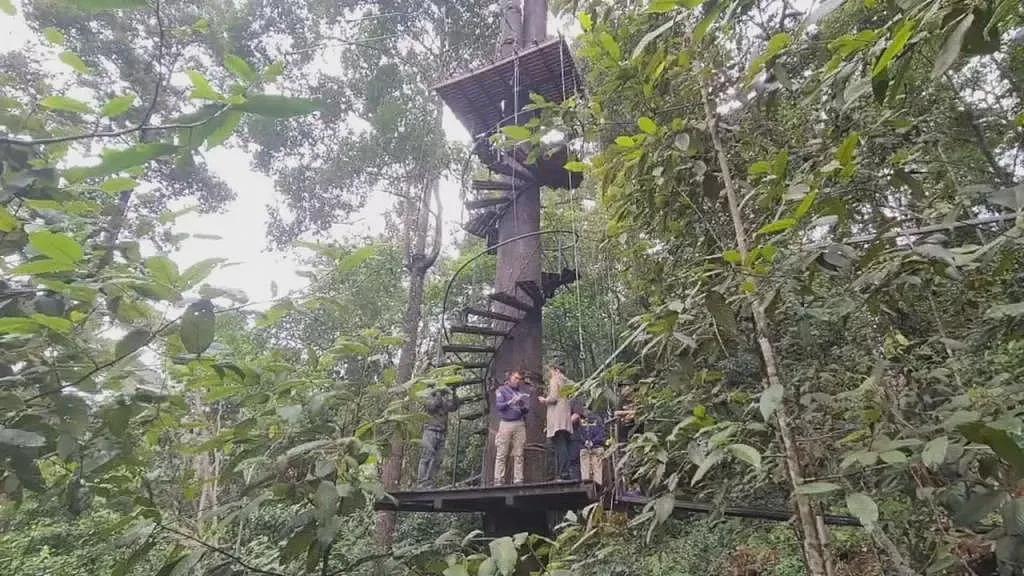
434,38 -> 583,137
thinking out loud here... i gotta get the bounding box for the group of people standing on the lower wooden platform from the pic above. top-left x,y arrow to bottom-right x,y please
419,366 -> 608,487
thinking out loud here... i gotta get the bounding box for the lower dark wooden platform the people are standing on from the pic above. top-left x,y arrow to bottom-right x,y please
374,481 -> 598,512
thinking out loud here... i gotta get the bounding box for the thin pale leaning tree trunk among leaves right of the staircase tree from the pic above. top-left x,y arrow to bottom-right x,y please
700,75 -> 831,576
